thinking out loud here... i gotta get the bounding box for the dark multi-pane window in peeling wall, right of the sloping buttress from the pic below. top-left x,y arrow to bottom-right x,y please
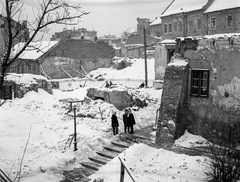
191,70 -> 209,97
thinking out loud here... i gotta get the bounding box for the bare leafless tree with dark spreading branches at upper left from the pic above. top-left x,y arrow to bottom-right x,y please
0,0 -> 89,92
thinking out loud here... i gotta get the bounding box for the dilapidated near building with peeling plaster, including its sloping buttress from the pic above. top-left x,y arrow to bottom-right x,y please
156,34 -> 240,147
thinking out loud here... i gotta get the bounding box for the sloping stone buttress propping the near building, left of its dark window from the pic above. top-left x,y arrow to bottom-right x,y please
156,59 -> 188,147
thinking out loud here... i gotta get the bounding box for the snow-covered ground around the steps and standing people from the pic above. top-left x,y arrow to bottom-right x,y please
0,59 -> 210,182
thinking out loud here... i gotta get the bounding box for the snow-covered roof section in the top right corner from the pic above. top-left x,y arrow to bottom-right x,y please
204,0 -> 240,13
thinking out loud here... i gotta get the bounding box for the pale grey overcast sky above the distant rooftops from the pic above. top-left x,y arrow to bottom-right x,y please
0,0 -> 172,40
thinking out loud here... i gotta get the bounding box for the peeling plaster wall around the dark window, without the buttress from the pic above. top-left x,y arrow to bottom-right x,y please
184,36 -> 240,140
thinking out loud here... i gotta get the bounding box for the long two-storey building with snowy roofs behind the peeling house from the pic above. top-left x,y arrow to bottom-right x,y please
161,0 -> 240,40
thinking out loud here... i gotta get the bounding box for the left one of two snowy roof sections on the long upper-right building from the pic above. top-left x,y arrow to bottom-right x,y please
161,0 -> 208,17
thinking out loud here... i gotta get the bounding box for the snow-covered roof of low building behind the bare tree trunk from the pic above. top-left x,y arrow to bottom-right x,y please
11,41 -> 58,60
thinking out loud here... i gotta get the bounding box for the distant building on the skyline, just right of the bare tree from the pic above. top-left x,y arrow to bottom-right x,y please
51,28 -> 97,41
